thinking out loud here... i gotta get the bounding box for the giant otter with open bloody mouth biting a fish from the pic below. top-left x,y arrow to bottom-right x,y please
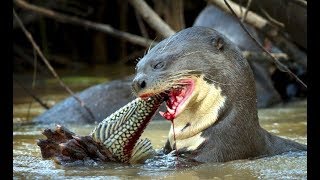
132,27 -> 307,162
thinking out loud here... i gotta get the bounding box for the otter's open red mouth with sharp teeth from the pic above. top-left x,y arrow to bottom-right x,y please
159,79 -> 194,121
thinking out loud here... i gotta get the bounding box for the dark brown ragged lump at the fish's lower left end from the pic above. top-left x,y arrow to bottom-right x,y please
37,125 -> 115,165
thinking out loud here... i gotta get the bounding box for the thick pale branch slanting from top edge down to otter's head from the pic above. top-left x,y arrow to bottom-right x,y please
129,0 -> 175,38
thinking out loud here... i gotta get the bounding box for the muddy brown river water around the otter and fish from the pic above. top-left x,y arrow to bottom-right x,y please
13,68 -> 307,179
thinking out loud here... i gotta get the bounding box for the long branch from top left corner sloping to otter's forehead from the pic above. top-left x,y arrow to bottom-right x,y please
14,0 -> 152,47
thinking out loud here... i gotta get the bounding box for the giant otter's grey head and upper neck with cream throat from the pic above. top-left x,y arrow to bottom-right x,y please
132,27 -> 256,153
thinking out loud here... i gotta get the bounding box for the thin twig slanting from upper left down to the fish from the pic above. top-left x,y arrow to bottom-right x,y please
13,9 -> 95,121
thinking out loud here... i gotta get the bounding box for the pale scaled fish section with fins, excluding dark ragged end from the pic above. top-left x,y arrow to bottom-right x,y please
90,97 -> 162,164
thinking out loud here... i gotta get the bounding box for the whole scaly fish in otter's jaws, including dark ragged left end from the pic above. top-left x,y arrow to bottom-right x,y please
37,96 -> 164,165
